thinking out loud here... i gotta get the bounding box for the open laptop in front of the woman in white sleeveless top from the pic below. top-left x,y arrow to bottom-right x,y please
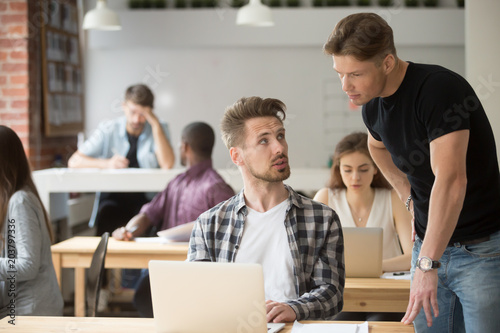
342,228 -> 383,277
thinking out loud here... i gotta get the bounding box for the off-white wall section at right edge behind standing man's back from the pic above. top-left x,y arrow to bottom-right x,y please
465,0 -> 500,160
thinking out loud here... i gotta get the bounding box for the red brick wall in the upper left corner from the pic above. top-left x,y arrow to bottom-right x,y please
0,0 -> 76,170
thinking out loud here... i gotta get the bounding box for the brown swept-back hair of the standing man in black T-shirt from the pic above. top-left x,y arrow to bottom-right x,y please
323,13 -> 396,63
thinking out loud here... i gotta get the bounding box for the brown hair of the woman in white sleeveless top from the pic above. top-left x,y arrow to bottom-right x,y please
328,132 -> 392,190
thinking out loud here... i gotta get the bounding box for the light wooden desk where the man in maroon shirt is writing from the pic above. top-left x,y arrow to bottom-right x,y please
52,237 -> 188,317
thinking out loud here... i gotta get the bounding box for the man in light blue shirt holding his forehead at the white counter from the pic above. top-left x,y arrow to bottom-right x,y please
68,84 -> 175,235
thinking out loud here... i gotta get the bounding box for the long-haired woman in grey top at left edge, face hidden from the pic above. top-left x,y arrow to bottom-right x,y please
0,125 -> 64,318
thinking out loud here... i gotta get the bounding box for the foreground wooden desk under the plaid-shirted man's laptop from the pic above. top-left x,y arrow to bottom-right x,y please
0,316 -> 415,333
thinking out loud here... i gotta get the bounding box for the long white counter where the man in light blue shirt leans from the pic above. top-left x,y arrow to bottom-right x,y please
33,167 -> 330,219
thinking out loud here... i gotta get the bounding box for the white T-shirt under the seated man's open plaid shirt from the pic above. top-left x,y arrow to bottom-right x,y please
235,200 -> 297,302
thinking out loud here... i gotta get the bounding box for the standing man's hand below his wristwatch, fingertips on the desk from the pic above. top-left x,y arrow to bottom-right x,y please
401,268 -> 439,327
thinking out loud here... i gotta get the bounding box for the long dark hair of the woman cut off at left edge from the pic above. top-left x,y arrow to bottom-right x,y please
0,125 -> 54,242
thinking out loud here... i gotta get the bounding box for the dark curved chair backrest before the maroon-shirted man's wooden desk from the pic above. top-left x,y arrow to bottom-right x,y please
86,232 -> 109,317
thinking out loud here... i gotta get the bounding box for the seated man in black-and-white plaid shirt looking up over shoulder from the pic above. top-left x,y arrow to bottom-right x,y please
188,97 -> 345,322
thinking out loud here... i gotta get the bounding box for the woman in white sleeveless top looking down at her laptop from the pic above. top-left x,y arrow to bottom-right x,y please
314,133 -> 413,272
